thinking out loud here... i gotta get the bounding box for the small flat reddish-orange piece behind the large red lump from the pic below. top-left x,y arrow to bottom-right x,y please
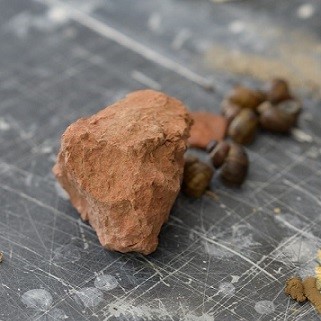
188,112 -> 227,149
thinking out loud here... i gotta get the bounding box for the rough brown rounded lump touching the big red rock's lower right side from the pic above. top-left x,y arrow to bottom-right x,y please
182,156 -> 214,198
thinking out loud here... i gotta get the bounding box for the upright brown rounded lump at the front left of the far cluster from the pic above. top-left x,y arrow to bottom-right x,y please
228,108 -> 258,145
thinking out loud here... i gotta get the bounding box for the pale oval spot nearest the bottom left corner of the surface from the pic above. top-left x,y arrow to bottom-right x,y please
21,289 -> 53,311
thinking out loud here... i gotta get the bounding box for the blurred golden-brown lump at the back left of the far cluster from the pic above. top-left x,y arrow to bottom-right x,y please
227,86 -> 266,110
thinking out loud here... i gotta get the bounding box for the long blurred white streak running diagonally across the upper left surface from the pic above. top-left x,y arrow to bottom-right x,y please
43,0 -> 213,89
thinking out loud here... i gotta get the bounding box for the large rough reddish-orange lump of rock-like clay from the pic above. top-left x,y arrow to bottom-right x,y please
53,90 -> 192,254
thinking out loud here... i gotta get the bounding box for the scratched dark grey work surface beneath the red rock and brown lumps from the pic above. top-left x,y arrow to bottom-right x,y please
0,0 -> 321,321
